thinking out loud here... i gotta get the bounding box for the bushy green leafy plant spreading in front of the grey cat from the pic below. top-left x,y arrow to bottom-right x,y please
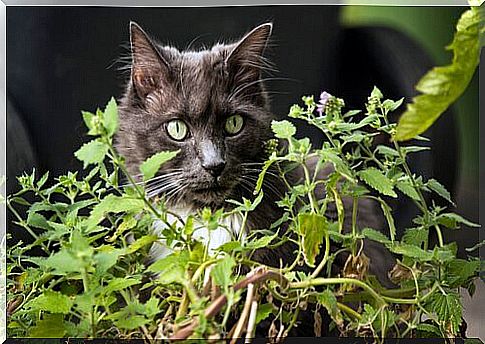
7,88 -> 480,339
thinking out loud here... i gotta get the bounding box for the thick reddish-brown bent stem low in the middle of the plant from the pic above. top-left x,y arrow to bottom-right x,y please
170,267 -> 289,340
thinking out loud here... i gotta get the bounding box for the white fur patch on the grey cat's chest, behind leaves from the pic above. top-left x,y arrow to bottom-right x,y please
150,208 -> 246,260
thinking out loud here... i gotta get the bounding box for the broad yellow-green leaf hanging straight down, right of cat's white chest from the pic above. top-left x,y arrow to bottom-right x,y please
298,213 -> 328,267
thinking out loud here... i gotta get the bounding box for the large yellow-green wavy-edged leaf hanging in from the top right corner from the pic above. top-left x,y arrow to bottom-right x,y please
395,7 -> 483,141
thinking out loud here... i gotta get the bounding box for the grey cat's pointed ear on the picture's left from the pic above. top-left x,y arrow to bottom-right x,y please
130,22 -> 170,98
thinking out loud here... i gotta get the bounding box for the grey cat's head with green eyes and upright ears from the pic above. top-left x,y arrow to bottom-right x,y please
116,23 -> 272,208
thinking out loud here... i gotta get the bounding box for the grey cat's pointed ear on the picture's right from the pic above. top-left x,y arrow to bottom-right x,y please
225,23 -> 273,78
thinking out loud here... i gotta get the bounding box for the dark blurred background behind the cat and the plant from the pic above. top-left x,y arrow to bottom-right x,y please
7,5 -> 485,338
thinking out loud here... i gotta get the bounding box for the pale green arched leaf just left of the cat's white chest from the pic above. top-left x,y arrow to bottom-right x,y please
85,194 -> 144,231
